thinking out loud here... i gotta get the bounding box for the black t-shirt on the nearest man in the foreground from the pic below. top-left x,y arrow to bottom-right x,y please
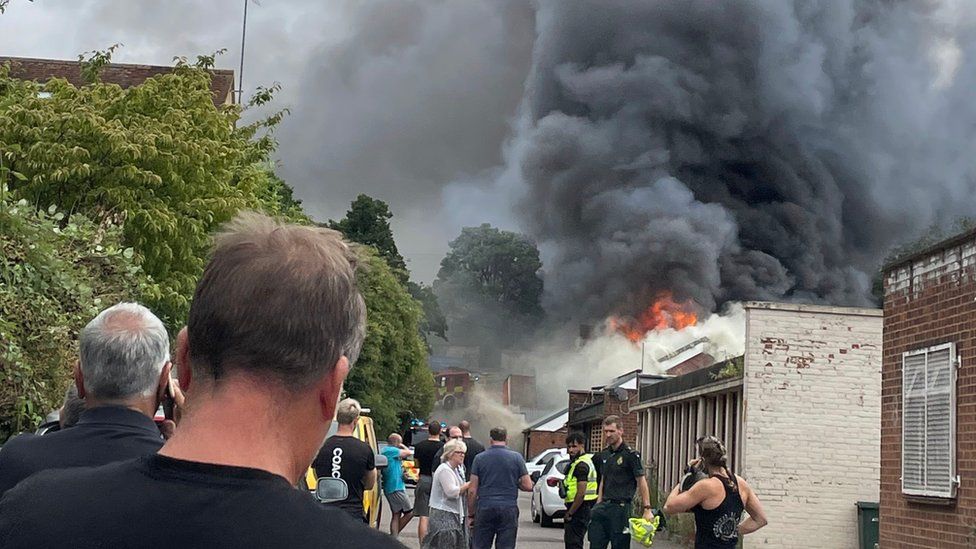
0,455 -> 403,549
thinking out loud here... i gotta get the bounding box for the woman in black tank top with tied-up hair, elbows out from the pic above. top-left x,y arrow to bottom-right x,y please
664,436 -> 766,549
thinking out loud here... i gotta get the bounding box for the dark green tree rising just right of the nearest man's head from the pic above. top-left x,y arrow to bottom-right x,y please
329,194 -> 410,283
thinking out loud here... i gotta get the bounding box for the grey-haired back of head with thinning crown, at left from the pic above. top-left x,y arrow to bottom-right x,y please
78,303 -> 169,401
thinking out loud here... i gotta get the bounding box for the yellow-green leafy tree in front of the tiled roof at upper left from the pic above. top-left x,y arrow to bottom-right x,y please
0,53 -> 288,328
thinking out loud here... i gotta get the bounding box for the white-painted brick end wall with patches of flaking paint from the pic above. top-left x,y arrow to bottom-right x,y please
740,303 -> 882,549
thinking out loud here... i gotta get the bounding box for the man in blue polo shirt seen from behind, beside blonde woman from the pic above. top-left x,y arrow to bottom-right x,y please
468,427 -> 532,549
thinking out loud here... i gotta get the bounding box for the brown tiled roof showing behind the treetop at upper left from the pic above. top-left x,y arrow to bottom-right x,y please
0,56 -> 234,105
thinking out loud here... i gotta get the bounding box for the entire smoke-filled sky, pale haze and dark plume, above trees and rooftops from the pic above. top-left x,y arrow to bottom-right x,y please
0,0 -> 976,324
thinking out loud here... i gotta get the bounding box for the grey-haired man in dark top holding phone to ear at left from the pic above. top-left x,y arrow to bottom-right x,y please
0,303 -> 171,496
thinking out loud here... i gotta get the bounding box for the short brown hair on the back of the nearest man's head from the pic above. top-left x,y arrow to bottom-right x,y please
187,213 -> 366,393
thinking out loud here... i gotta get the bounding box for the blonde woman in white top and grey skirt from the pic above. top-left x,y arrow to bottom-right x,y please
422,439 -> 471,549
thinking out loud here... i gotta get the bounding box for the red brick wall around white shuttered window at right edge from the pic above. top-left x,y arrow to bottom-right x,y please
881,229 -> 976,549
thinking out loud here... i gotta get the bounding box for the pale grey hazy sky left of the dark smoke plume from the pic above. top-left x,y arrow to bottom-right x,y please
0,0 -> 534,282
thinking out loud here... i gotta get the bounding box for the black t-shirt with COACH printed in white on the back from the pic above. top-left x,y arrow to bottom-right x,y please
312,435 -> 376,517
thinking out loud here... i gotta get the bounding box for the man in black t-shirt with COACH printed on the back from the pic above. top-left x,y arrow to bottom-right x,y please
312,398 -> 376,524
